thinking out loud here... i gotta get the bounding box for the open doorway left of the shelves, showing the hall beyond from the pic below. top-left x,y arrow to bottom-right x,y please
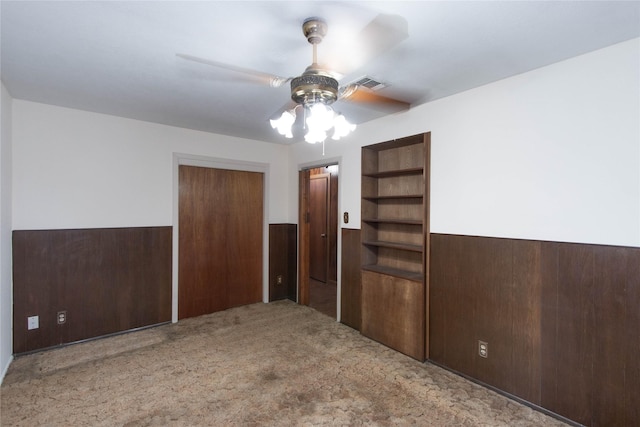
299,165 -> 338,318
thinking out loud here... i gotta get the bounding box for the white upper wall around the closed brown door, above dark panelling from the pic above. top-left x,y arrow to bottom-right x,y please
13,99 -> 289,229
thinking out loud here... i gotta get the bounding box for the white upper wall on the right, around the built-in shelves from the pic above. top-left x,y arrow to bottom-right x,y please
289,39 -> 640,251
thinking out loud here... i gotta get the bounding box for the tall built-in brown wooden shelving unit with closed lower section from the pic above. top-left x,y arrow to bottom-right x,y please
361,133 -> 430,360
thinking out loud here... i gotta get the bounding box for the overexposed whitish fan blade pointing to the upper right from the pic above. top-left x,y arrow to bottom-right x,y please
326,14 -> 409,75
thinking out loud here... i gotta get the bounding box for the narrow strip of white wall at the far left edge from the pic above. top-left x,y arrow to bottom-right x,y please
0,84 -> 13,384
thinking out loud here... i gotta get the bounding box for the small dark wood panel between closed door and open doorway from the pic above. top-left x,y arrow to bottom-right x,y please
269,224 -> 297,301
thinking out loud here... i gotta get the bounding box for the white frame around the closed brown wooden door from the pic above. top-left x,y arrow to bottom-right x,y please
171,152 -> 270,323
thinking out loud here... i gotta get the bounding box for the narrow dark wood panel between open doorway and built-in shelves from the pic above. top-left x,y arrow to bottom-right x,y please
340,228 -> 362,331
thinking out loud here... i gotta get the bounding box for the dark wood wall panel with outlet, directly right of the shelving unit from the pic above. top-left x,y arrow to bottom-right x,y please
429,235 -> 516,390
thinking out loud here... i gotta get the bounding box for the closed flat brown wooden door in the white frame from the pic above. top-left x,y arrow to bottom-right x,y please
178,165 -> 264,319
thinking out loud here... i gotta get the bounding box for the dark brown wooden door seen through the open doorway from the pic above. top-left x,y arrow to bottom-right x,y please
309,174 -> 329,282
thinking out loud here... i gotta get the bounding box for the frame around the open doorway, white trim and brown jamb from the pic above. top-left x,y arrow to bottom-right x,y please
298,157 -> 344,322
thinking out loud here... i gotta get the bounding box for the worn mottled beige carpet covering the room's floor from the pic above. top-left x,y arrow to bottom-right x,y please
1,301 -> 564,426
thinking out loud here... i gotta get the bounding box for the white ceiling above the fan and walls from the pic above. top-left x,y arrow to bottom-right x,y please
0,0 -> 640,143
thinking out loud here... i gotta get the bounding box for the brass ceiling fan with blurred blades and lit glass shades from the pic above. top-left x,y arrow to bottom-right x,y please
177,15 -> 410,146
